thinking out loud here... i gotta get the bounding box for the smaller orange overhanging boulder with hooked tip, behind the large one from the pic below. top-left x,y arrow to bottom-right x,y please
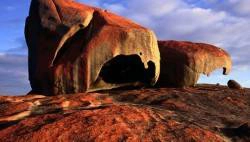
157,40 -> 232,87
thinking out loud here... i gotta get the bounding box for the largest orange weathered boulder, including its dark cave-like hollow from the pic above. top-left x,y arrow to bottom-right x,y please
25,0 -> 160,95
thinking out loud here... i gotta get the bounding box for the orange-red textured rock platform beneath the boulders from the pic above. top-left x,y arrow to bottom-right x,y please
0,85 -> 250,142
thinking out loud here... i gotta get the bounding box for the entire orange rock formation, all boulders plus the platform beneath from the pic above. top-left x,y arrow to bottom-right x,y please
0,0 -> 246,142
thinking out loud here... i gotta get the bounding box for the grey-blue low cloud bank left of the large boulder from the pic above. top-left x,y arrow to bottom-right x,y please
0,53 -> 30,95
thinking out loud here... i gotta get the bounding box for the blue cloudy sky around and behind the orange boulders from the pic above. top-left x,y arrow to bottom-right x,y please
0,0 -> 250,95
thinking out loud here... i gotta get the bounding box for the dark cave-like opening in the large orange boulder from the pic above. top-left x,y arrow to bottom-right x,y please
100,55 -> 155,84
